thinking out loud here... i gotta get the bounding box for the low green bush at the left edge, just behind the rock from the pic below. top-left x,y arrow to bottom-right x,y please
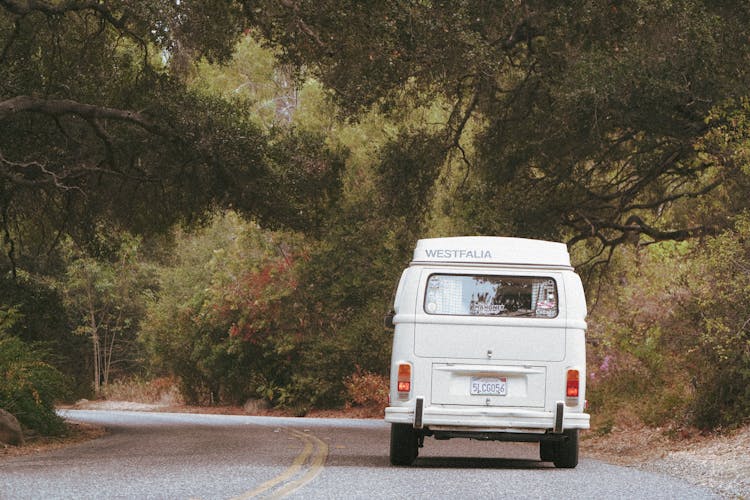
0,309 -> 66,435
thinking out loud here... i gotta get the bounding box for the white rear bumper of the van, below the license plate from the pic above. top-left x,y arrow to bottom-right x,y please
385,405 -> 590,433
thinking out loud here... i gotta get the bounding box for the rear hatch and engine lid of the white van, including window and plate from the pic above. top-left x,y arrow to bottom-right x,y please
414,268 -> 565,407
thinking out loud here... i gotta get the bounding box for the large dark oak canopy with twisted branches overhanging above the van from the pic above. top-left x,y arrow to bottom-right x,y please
245,0 -> 750,258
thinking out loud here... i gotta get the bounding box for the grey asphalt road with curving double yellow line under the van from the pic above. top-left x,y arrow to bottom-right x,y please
0,411 -> 713,500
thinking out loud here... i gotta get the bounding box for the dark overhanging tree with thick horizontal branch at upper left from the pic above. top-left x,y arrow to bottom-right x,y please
0,0 -> 340,273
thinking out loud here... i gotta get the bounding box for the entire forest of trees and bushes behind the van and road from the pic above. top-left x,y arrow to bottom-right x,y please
0,0 -> 750,434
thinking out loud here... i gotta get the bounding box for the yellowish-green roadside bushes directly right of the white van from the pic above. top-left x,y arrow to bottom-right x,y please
588,224 -> 750,429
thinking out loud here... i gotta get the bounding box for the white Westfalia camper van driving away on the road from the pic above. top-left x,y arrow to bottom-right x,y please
385,237 -> 589,468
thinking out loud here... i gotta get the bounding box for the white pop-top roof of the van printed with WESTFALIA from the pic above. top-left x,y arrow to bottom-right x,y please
412,236 -> 570,267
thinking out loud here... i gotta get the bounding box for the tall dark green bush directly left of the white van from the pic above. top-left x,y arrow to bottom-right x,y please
284,209 -> 415,407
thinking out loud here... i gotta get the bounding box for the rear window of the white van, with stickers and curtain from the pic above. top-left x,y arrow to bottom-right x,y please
424,274 -> 558,318
